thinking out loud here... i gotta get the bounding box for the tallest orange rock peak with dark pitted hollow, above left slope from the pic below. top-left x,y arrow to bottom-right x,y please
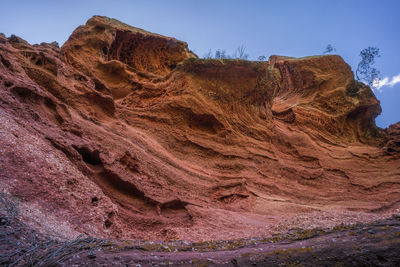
62,16 -> 197,78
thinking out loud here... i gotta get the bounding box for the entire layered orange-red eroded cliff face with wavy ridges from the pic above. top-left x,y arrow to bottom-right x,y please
0,16 -> 400,243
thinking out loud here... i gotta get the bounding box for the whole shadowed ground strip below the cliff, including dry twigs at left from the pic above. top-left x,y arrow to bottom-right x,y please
0,194 -> 400,266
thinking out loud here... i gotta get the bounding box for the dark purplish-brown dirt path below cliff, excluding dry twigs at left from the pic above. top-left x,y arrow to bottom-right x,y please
62,217 -> 400,266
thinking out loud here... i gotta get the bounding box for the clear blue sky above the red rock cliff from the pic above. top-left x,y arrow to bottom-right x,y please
0,0 -> 400,128
